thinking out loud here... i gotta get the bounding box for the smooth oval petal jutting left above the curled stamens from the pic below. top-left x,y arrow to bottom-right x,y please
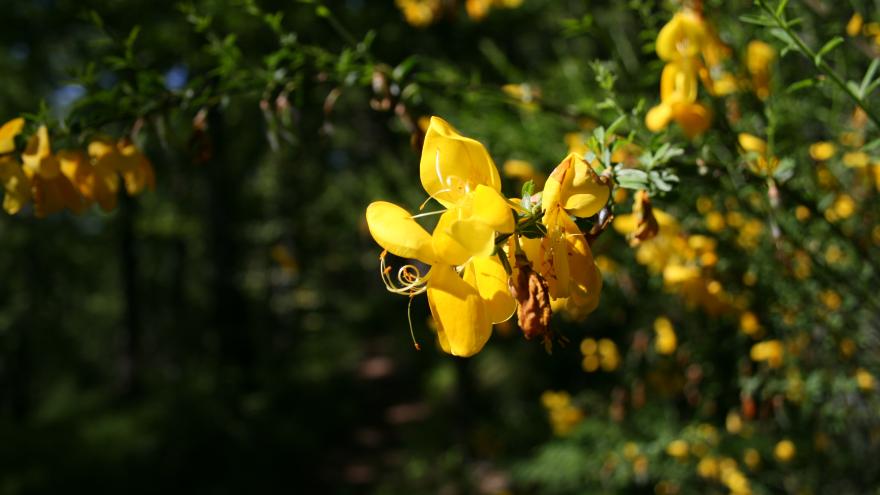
367,201 -> 435,264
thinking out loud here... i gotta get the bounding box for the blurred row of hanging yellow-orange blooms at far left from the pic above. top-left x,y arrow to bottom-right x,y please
0,118 -> 155,217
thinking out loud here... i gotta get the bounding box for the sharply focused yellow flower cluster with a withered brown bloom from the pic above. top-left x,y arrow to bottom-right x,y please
366,117 -> 611,356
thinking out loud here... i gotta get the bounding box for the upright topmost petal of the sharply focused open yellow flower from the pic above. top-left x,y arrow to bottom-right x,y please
419,117 -> 501,208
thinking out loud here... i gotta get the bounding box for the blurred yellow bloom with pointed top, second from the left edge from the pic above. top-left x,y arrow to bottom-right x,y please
21,126 -> 85,217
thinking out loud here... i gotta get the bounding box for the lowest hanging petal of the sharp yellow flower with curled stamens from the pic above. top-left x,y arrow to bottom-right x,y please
427,265 -> 492,357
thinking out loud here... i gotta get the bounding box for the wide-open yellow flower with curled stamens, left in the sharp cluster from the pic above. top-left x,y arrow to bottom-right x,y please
366,117 -> 516,356
